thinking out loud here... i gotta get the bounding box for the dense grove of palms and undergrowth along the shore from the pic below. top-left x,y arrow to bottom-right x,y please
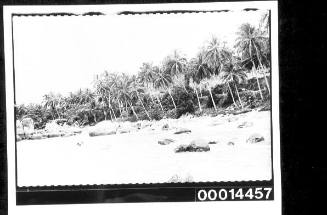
16,17 -> 270,129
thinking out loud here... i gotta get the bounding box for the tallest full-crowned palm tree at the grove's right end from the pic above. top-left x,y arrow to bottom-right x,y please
235,23 -> 270,99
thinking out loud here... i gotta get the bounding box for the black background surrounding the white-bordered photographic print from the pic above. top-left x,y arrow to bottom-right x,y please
0,0 -> 327,215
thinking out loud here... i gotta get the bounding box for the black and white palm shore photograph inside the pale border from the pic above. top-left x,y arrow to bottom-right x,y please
5,0 -> 279,210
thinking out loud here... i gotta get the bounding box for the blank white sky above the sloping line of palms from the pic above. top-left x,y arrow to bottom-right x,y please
14,11 -> 265,104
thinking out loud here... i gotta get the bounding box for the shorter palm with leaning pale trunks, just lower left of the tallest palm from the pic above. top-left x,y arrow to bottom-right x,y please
221,59 -> 247,109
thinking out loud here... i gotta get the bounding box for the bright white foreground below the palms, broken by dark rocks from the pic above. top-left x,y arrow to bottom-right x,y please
17,111 -> 272,186
